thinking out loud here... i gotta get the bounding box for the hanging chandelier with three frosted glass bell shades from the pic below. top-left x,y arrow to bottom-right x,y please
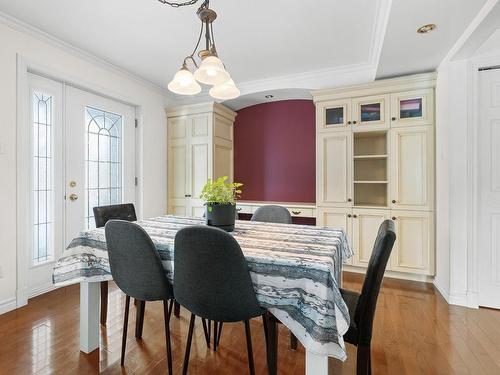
158,0 -> 240,100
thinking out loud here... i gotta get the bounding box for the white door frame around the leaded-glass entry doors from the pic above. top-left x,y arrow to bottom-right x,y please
16,54 -> 145,308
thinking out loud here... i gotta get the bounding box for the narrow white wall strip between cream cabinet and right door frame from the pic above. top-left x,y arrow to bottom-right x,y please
435,60 -> 468,304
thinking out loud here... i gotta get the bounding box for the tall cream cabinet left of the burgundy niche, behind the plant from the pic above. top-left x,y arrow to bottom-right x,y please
167,103 -> 236,217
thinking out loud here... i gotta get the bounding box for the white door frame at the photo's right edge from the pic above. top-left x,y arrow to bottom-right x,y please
467,51 -> 500,308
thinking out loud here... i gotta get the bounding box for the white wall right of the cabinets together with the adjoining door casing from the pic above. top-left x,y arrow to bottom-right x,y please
434,30 -> 500,307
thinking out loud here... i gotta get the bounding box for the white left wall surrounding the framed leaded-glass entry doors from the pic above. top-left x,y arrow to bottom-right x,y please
0,22 -> 167,313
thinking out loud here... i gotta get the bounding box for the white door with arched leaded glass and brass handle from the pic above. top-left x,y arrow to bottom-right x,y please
64,86 -> 135,245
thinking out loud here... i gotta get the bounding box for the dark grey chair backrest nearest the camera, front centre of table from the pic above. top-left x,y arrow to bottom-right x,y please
174,226 -> 264,322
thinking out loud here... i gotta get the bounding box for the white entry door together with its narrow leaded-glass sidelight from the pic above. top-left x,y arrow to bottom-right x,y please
25,74 -> 136,298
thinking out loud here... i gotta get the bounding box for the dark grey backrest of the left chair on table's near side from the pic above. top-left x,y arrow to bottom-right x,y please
105,220 -> 173,301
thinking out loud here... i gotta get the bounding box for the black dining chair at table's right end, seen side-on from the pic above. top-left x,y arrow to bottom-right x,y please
340,220 -> 396,375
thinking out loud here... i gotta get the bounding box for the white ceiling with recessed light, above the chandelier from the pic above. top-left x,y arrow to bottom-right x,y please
0,0 -> 494,107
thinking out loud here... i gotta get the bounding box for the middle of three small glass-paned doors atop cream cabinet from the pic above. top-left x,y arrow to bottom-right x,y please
352,95 -> 390,131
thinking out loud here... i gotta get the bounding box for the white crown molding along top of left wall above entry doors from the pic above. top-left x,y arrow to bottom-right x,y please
0,11 -> 173,99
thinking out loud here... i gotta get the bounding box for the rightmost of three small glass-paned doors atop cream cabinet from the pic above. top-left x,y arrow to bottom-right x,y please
391,89 -> 434,126
